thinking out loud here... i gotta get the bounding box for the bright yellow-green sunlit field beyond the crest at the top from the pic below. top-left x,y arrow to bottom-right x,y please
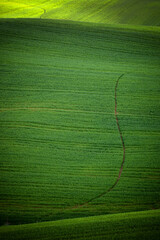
0,0 -> 160,26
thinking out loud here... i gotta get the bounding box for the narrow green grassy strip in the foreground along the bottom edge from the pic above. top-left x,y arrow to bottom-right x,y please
0,210 -> 160,240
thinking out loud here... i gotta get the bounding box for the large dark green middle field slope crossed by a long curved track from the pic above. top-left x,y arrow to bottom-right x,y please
0,19 -> 160,224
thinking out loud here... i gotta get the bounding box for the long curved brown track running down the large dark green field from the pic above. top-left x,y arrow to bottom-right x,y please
72,74 -> 125,208
